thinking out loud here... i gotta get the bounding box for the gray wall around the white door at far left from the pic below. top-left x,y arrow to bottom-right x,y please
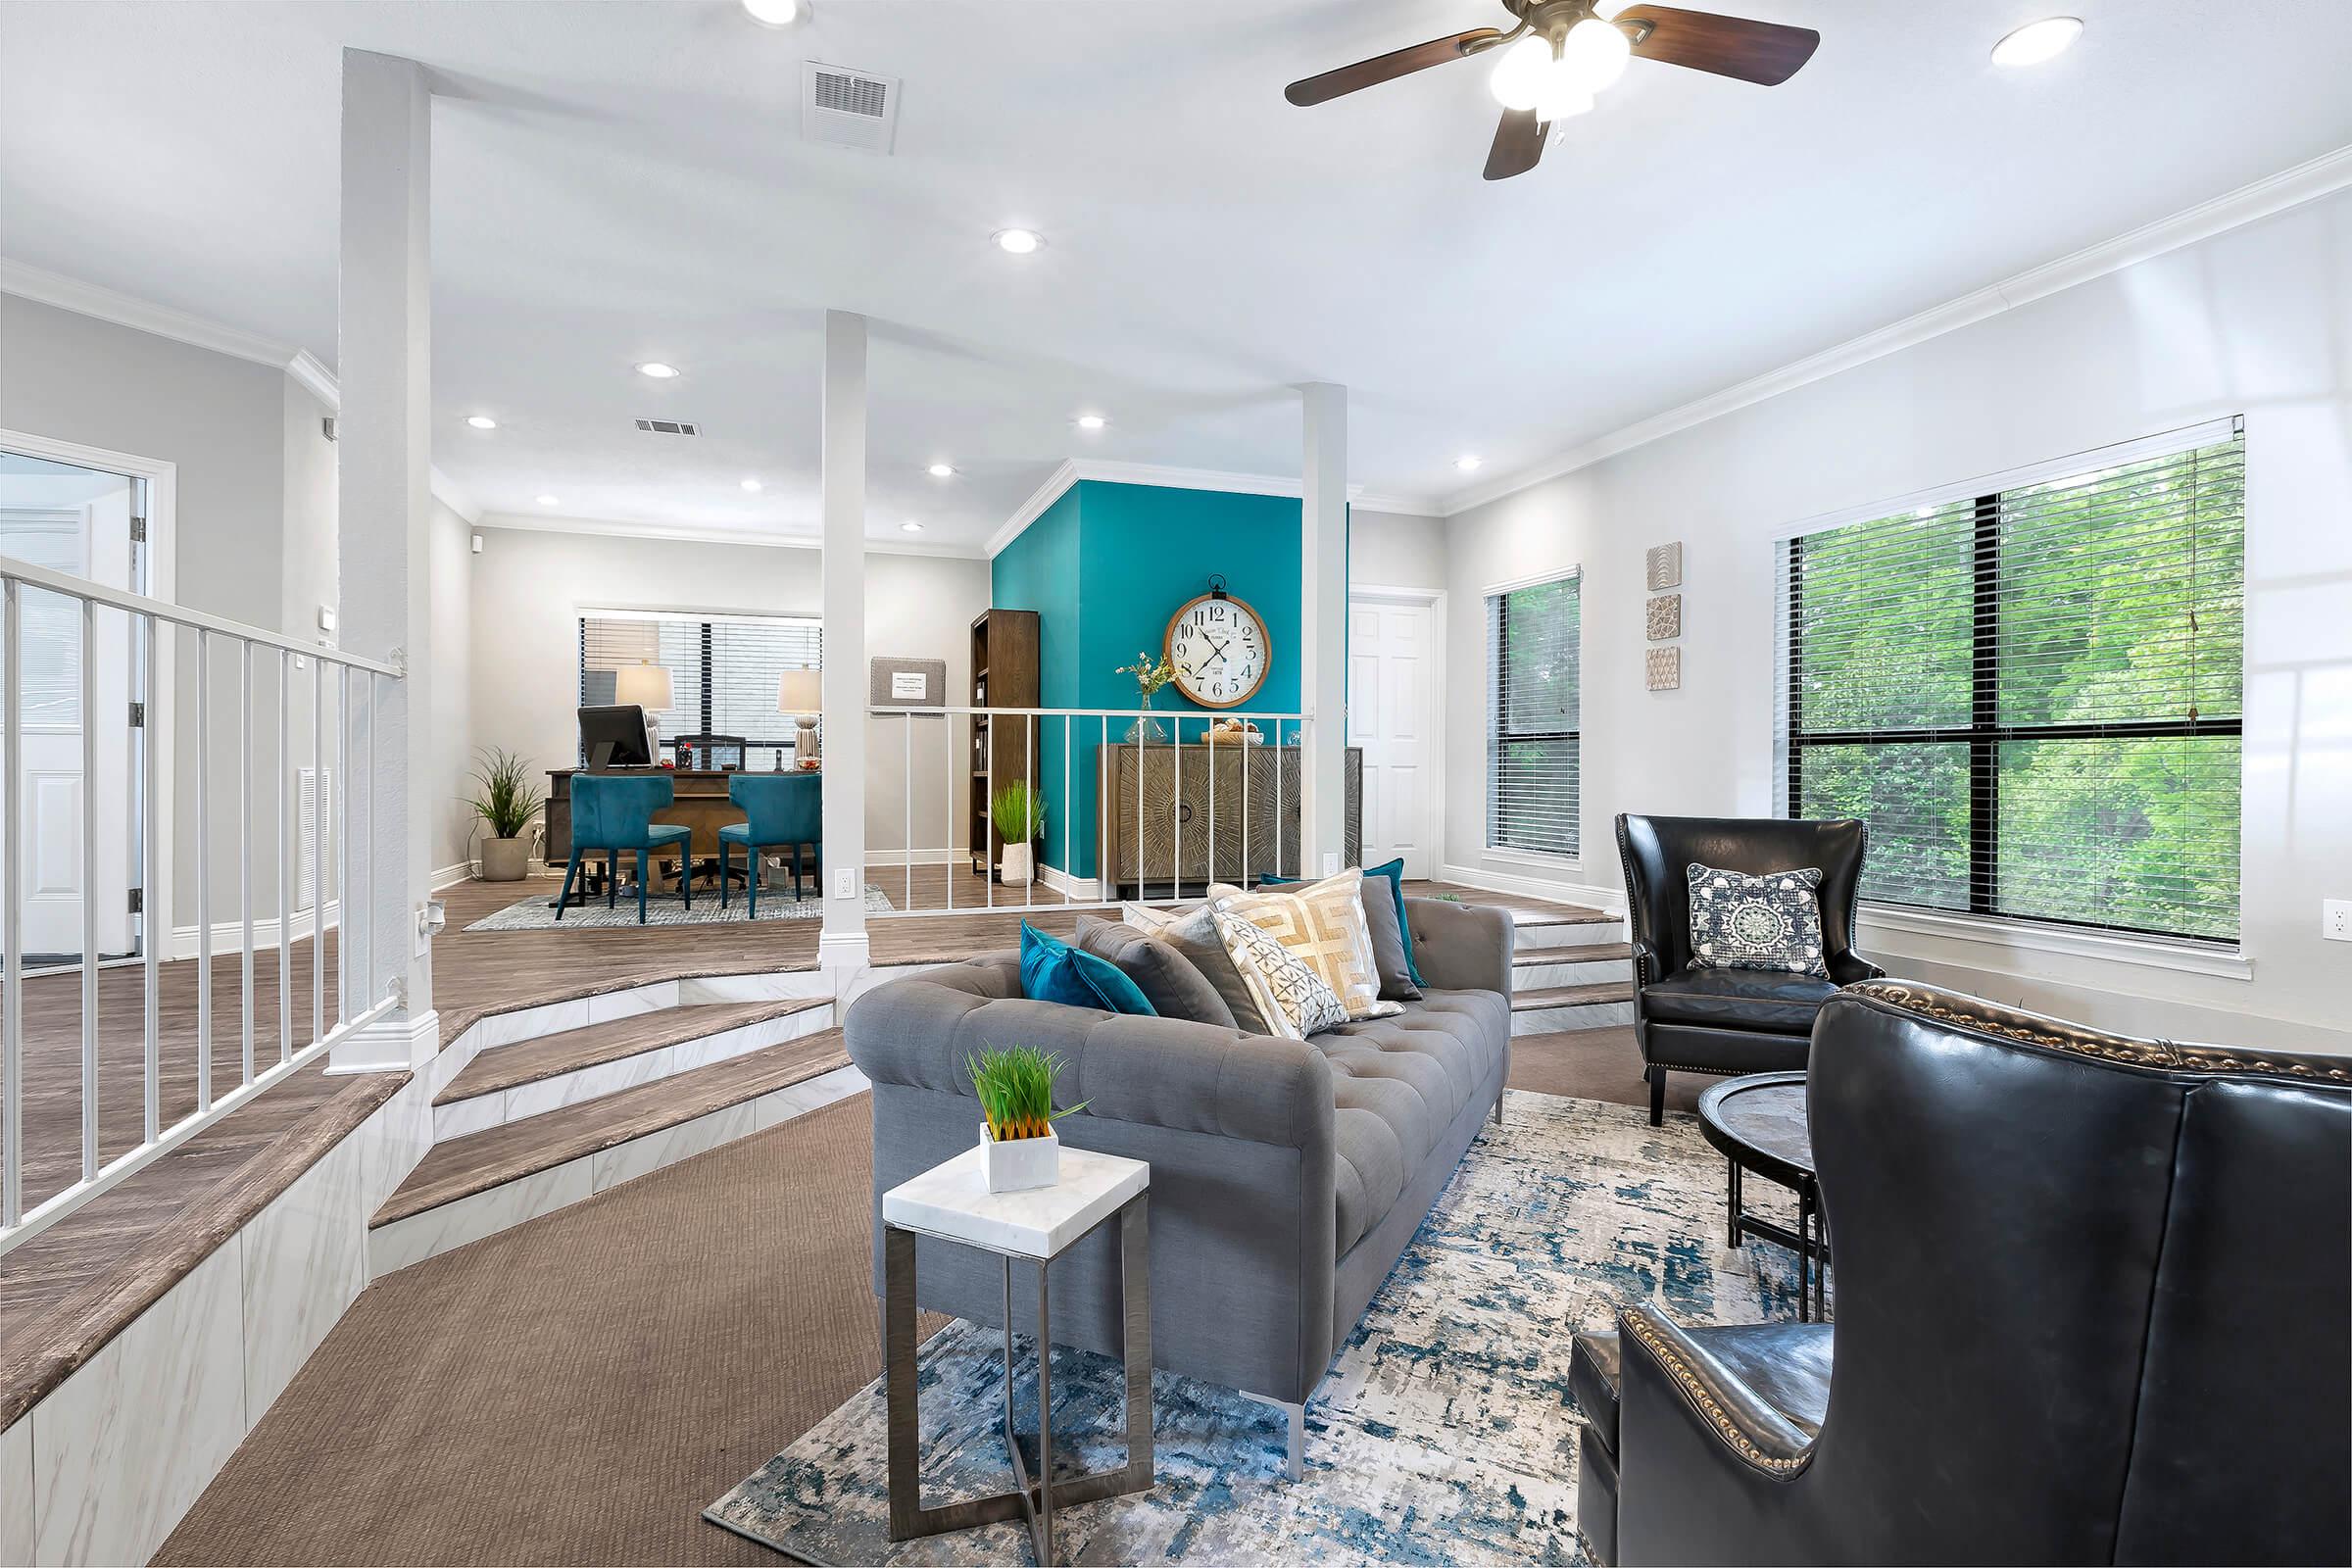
0,294 -> 334,926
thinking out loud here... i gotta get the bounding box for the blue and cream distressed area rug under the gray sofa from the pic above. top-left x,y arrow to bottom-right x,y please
704,1091 -> 1797,1566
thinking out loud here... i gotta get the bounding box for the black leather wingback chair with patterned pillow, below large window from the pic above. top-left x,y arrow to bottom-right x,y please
1618,813 -> 1886,1126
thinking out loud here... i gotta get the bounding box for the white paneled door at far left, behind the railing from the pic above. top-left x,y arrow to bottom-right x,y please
0,454 -> 139,966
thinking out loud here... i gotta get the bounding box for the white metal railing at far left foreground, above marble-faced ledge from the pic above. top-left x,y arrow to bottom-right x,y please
0,558 -> 402,1253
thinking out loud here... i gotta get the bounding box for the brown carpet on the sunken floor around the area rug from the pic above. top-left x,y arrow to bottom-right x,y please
155,1030 -> 1674,1568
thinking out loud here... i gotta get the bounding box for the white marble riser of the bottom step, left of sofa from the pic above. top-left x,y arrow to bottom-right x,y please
367,1062 -> 868,1279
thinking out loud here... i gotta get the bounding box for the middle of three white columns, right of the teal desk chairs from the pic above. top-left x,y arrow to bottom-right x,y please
816,311 -> 865,968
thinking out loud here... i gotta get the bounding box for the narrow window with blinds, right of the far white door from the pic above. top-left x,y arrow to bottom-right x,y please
1487,576 -> 1581,856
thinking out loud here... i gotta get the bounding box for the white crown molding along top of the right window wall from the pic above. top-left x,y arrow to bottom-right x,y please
1442,137 -> 2352,517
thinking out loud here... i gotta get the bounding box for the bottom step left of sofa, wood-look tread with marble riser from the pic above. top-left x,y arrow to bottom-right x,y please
367,1027 -> 865,1277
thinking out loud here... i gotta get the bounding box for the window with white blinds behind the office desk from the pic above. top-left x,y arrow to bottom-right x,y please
581,609 -> 823,764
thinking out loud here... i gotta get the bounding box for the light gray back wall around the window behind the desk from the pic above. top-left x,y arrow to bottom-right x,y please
463,533 -> 988,854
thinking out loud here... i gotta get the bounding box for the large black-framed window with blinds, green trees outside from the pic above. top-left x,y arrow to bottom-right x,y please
1781,428 -> 2246,941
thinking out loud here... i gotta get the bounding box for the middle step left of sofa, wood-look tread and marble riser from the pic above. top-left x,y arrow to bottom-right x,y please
433,997 -> 833,1140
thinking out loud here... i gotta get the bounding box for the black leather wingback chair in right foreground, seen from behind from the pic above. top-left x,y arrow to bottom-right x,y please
1569,980 -> 2352,1563
